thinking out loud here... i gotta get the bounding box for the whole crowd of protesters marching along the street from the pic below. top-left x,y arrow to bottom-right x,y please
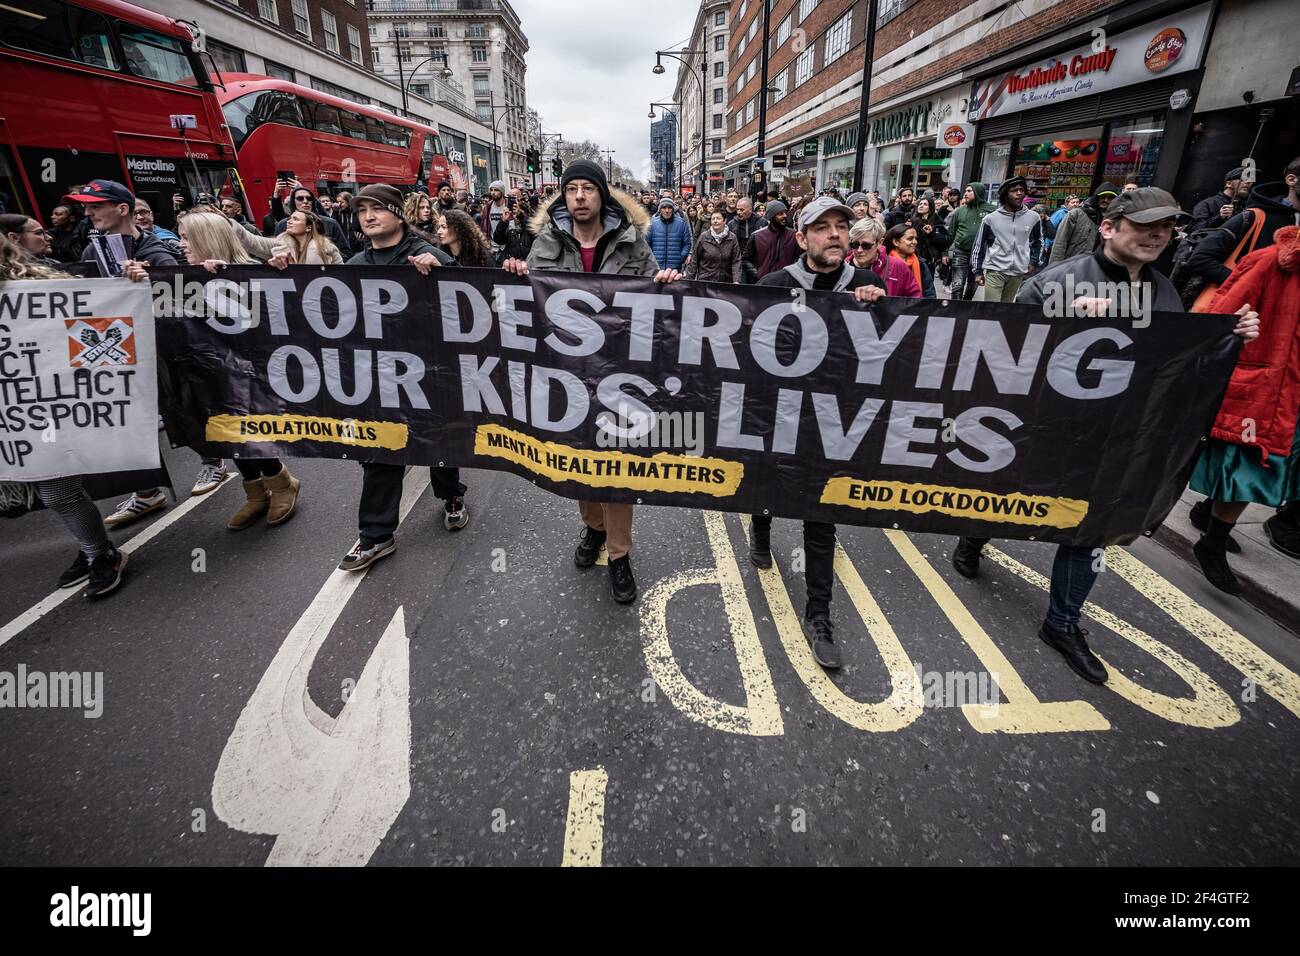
10,159 -> 1300,683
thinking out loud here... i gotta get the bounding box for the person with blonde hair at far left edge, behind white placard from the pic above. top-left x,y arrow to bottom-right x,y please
0,235 -> 126,598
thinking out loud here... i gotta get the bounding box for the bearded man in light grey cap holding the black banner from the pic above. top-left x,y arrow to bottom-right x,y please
749,196 -> 885,670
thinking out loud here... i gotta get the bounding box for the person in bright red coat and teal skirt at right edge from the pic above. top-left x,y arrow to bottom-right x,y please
1190,226 -> 1300,594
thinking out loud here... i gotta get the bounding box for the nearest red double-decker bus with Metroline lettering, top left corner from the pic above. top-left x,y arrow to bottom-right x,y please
0,0 -> 239,225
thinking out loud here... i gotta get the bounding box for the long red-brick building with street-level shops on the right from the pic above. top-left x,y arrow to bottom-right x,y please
724,0 -> 1297,209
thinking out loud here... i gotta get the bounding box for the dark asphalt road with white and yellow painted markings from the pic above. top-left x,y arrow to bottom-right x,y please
0,450 -> 1300,866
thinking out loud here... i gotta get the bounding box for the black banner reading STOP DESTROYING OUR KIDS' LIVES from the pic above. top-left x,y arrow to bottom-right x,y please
155,267 -> 1238,545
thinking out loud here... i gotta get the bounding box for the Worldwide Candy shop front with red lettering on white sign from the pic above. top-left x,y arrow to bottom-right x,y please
967,4 -> 1212,208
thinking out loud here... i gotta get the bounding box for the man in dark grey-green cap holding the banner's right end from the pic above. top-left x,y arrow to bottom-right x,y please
953,186 -> 1260,684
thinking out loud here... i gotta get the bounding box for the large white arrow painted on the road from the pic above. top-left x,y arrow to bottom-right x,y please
212,468 -> 429,866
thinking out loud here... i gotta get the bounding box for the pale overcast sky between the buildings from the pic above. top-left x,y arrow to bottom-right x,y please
511,0 -> 699,179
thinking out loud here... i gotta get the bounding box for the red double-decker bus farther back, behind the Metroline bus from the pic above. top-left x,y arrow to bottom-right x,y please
217,73 -> 447,219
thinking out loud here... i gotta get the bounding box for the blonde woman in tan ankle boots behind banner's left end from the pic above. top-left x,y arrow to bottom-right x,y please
152,209 -> 304,531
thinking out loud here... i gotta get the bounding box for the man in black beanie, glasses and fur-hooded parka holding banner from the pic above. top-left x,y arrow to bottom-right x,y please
502,160 -> 681,604
